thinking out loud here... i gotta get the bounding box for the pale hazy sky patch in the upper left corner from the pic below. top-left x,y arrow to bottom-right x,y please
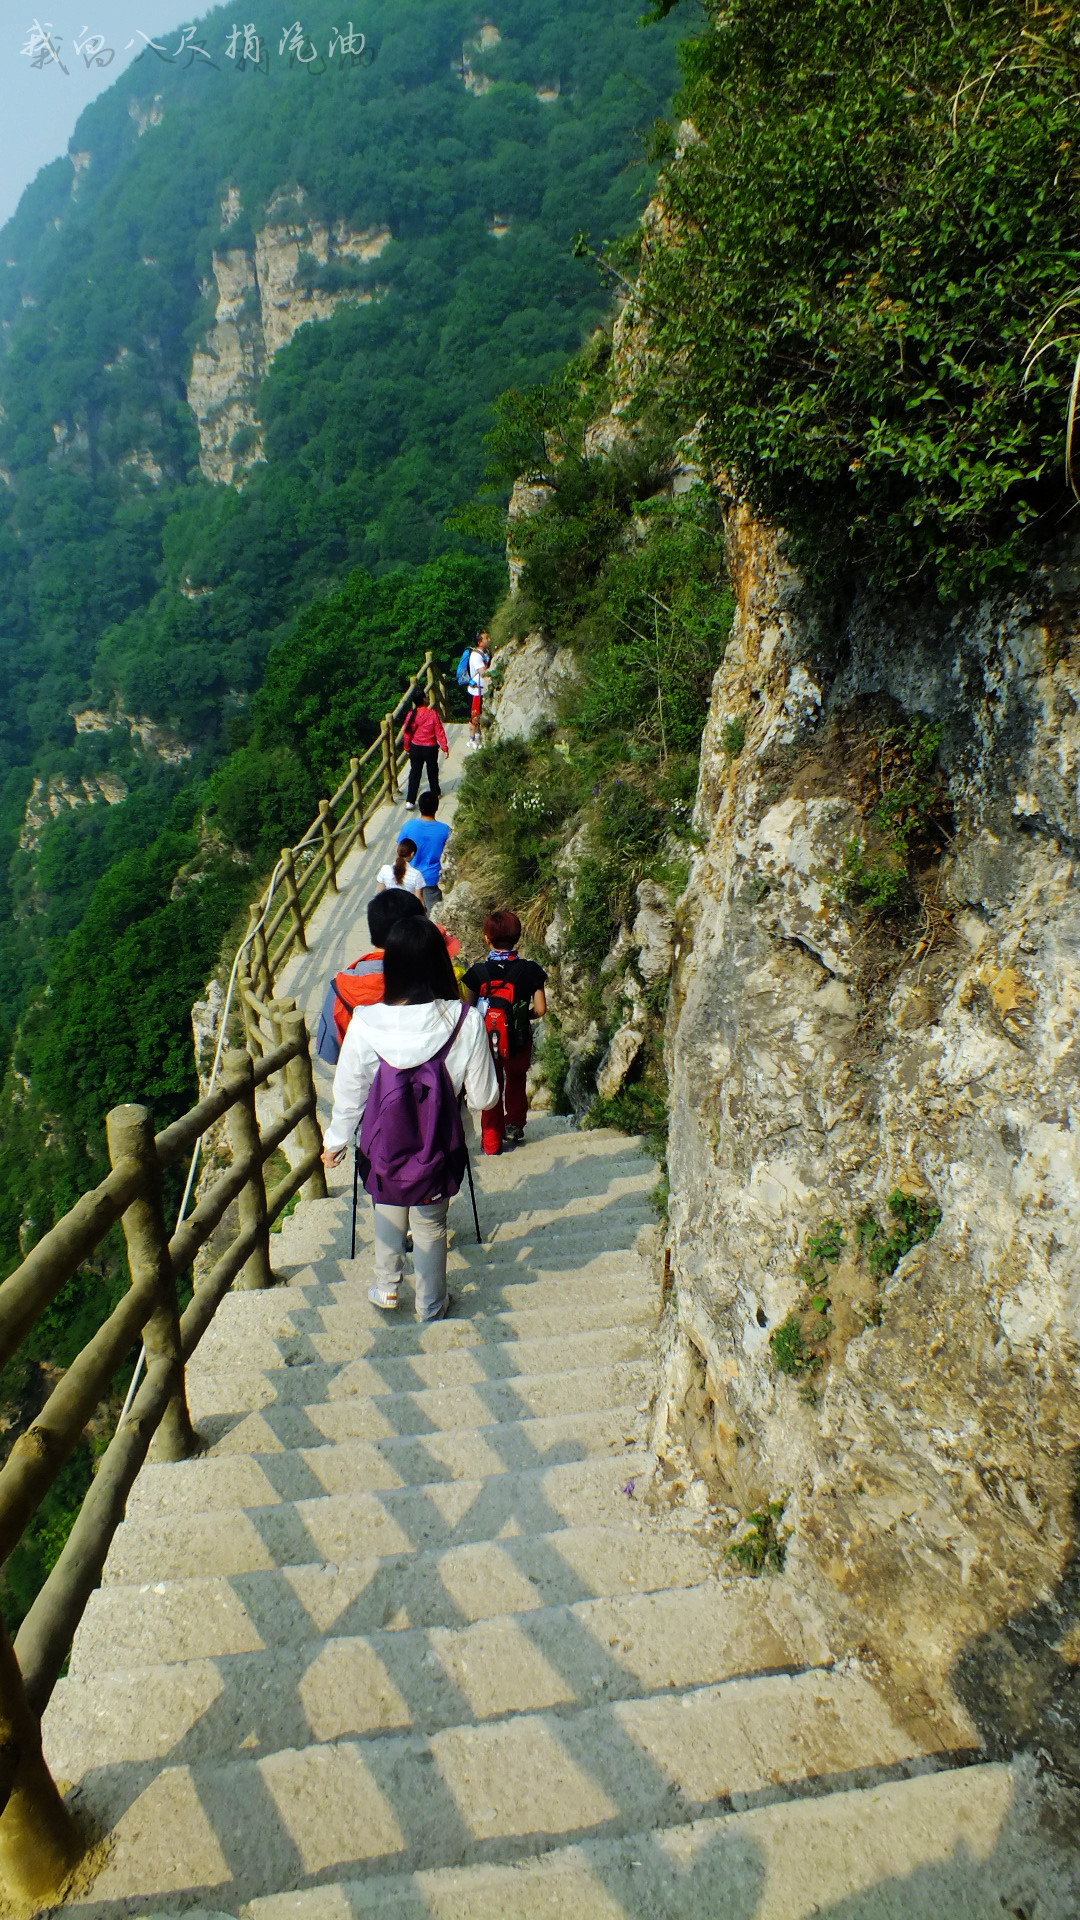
0,0 -> 208,227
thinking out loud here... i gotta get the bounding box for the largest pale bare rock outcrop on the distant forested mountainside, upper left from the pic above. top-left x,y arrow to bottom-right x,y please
188,188 -> 390,484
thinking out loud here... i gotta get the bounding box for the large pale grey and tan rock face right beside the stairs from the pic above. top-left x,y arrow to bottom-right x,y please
661,503 -> 1080,1768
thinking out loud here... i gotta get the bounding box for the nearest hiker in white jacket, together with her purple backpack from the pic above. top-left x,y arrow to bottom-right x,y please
323,918 -> 500,1321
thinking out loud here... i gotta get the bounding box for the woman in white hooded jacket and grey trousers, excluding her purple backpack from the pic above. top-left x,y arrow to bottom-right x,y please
323,916 -> 500,1321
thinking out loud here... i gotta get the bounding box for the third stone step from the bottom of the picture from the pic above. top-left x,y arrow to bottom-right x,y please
46,1582 -> 824,1780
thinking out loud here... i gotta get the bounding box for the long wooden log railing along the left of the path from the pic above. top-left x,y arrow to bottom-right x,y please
0,653 -> 444,1903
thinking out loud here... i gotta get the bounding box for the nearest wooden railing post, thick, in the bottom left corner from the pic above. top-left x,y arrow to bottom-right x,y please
0,1620 -> 83,1905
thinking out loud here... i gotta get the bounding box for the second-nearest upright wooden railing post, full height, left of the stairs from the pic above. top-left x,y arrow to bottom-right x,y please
106,1105 -> 194,1459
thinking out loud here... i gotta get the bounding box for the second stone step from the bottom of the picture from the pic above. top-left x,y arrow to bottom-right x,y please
58,1670 -> 922,1912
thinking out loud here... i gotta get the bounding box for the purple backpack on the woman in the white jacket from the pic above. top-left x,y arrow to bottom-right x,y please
356,1006 -> 469,1206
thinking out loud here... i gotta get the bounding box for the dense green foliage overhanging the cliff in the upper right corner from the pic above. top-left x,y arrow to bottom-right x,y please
642,0 -> 1080,593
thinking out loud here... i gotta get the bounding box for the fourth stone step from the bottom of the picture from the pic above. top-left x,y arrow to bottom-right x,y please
71,1524 -> 722,1674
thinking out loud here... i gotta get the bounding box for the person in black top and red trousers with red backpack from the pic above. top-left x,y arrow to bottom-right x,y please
465,912 -> 548,1154
